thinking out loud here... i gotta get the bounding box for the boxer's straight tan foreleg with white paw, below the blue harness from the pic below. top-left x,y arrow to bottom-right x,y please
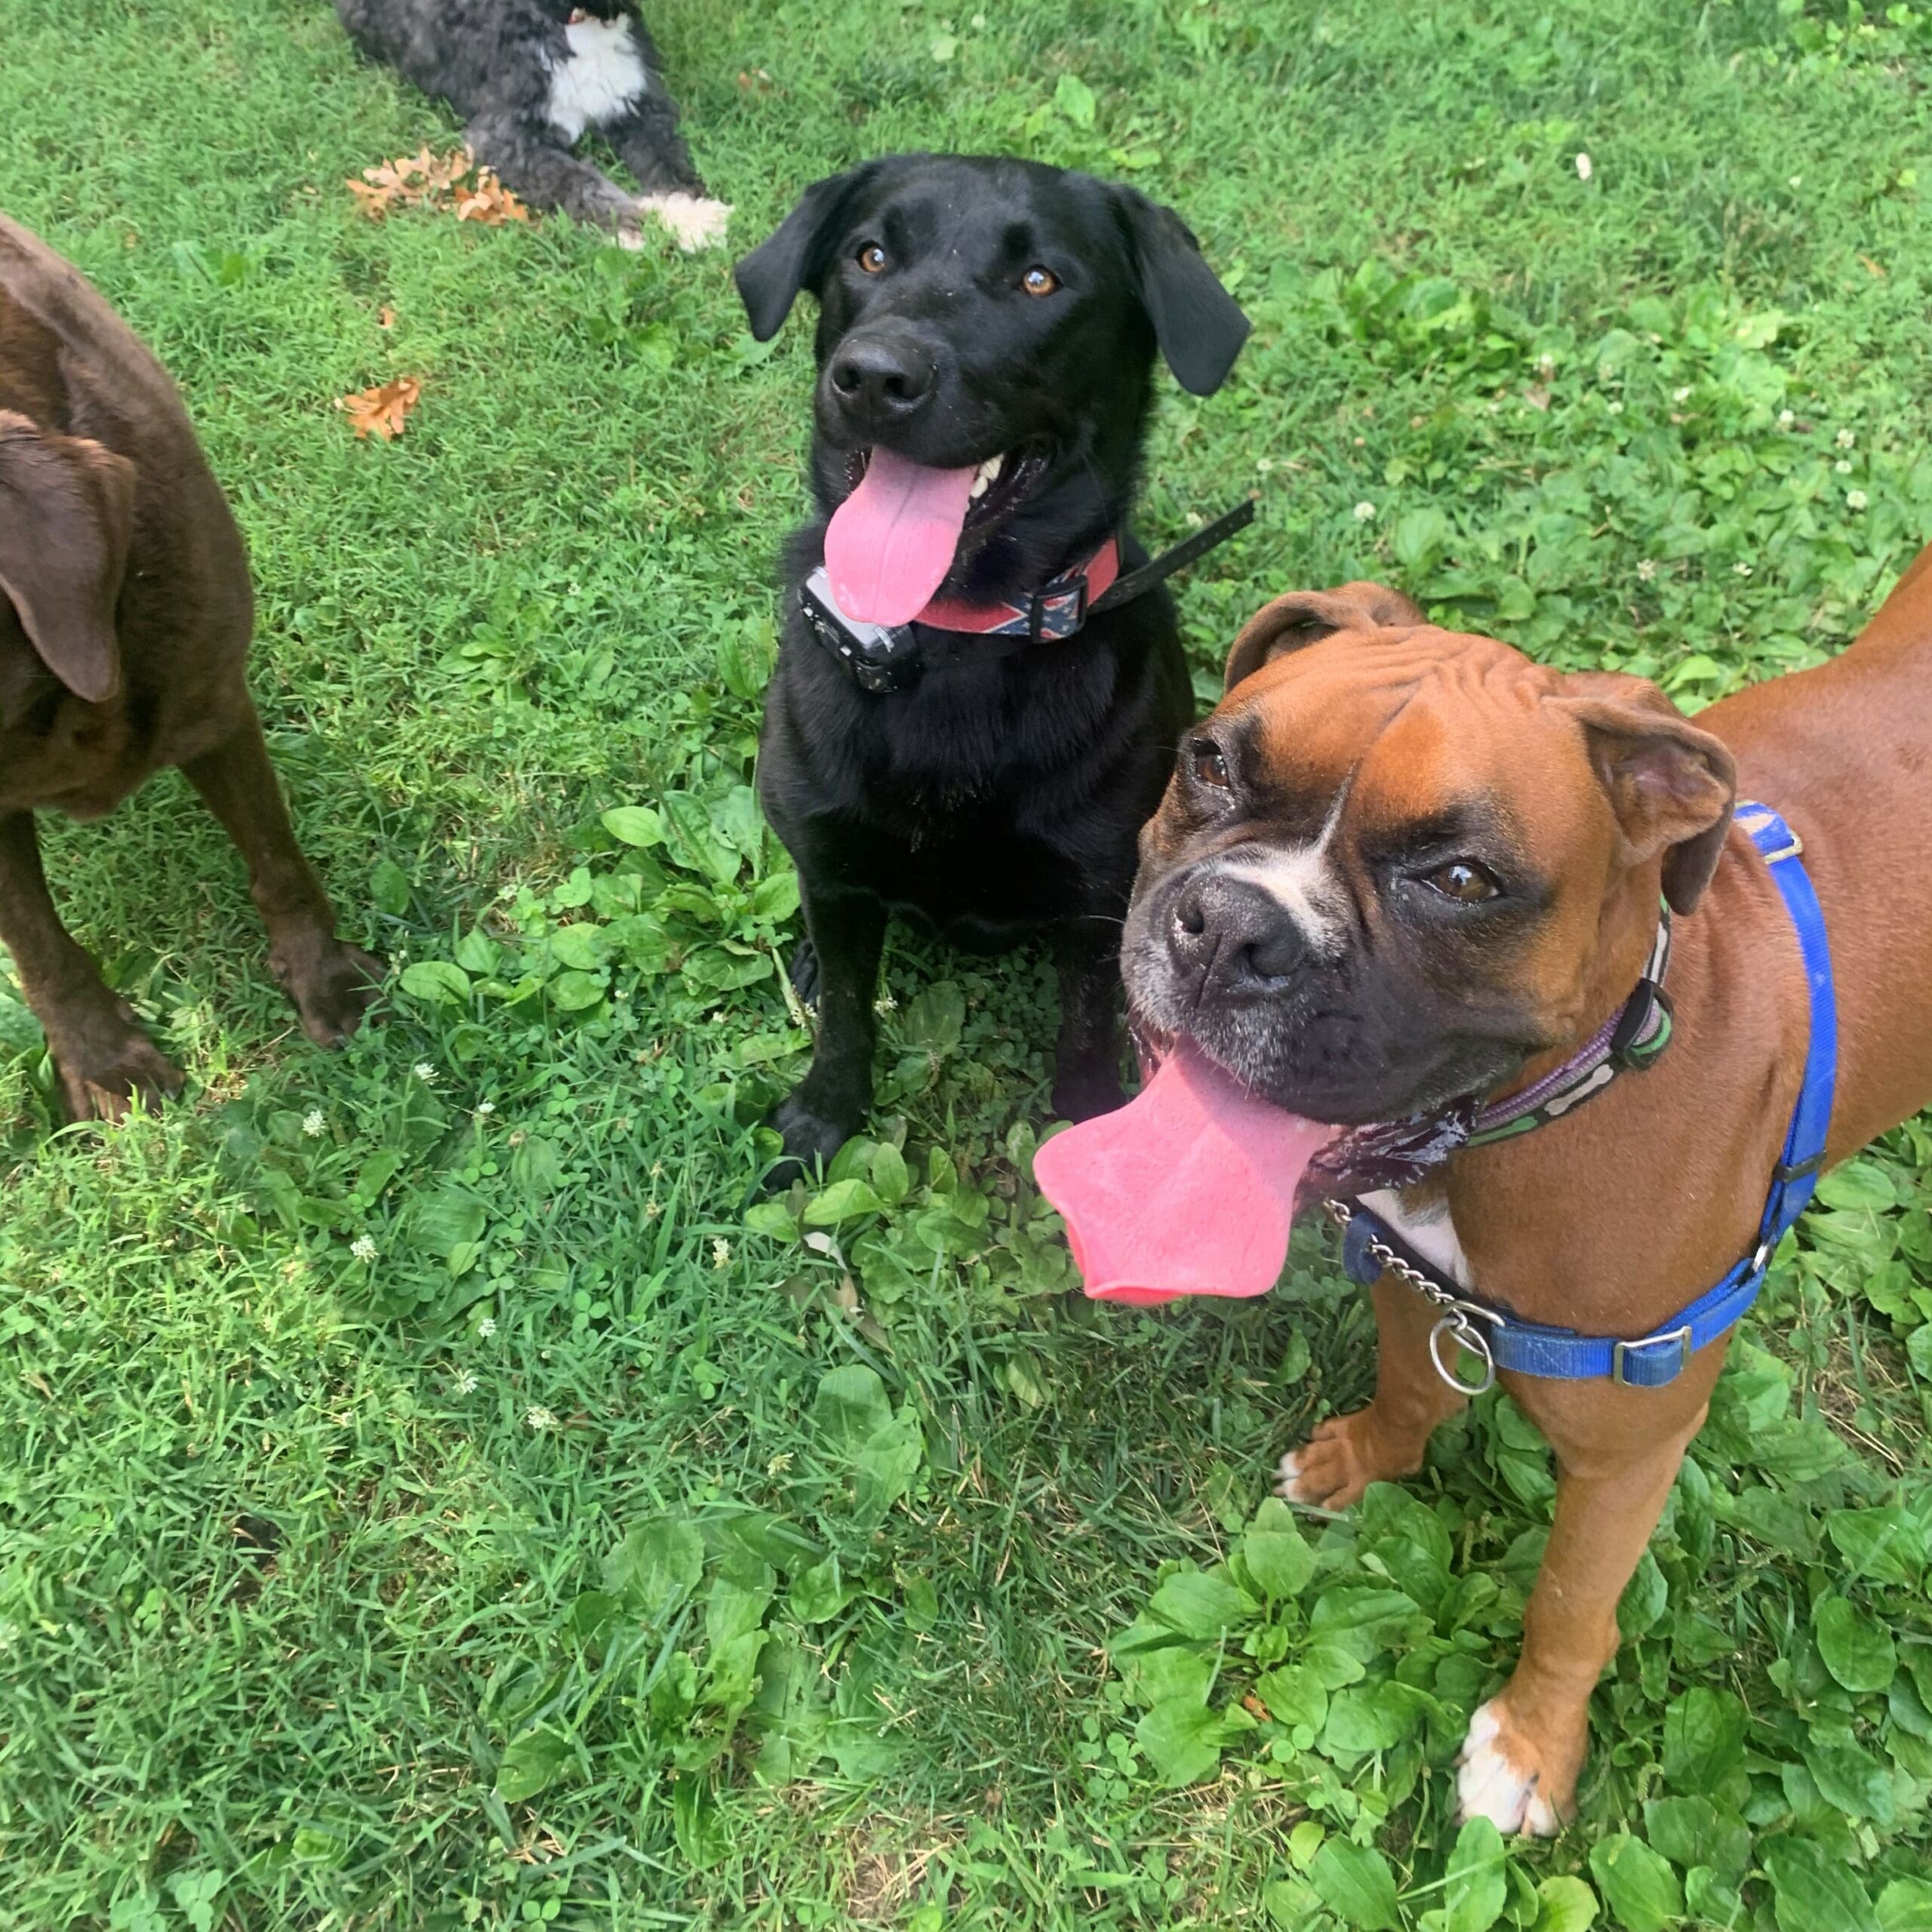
1457,1383 -> 1724,1838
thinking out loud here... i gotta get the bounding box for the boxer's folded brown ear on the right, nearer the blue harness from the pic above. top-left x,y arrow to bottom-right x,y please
1557,670 -> 1737,912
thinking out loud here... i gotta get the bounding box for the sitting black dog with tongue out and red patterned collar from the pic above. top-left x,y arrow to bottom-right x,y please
738,155 -> 1248,1173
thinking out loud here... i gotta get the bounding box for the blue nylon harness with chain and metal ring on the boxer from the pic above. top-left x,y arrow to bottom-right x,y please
1331,804 -> 1838,1395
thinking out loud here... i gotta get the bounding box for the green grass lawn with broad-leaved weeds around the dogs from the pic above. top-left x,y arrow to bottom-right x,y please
0,0 -> 1932,1932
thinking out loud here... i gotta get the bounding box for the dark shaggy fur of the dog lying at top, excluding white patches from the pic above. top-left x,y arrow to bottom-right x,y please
336,0 -> 726,245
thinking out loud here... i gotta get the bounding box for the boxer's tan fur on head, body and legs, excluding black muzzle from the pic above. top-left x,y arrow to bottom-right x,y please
1124,551 -> 1932,1832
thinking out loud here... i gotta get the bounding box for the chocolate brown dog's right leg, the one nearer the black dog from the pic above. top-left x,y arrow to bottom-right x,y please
182,707 -> 384,1048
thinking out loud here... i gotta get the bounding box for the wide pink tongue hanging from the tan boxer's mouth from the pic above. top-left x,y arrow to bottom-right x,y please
1034,1041 -> 1339,1302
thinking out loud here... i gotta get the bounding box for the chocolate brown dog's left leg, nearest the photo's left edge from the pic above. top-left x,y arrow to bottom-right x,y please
0,811 -> 182,1121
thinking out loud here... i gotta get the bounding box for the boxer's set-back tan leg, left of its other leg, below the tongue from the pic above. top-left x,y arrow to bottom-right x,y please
1275,1275 -> 1464,1509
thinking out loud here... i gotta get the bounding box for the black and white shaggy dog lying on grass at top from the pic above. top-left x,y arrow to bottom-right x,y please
336,0 -> 731,249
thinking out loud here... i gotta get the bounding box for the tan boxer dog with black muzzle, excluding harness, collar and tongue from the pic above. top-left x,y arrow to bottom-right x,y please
1122,551 -> 1932,1833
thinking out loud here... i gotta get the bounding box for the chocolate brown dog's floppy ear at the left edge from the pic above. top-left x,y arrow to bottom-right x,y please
0,410 -> 135,705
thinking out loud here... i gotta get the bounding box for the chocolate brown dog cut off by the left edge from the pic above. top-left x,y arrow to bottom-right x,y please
0,217 -> 383,1118
